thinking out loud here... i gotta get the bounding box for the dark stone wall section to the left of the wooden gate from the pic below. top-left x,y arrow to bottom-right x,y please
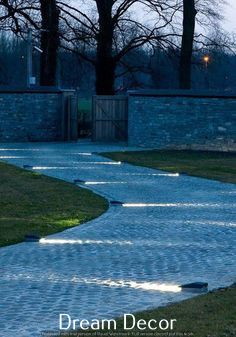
0,88 -> 75,142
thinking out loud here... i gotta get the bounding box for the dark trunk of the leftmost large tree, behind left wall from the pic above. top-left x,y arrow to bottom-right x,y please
40,0 -> 60,86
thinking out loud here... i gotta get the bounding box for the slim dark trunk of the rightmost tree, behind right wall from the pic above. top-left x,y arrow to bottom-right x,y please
179,0 -> 197,89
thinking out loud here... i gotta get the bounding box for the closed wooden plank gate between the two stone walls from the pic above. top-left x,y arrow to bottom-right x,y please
92,96 -> 128,141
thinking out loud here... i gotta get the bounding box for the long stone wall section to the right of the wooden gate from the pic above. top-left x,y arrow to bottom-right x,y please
128,91 -> 236,151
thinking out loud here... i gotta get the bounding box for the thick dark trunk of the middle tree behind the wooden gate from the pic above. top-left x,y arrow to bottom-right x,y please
96,0 -> 116,95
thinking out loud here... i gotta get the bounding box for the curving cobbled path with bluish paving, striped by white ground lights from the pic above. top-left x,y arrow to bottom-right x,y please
0,140 -> 236,337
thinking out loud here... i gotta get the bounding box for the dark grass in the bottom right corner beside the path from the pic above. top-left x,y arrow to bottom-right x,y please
63,287 -> 236,337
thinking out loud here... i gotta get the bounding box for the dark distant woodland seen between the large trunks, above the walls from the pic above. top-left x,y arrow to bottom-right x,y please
0,34 -> 236,96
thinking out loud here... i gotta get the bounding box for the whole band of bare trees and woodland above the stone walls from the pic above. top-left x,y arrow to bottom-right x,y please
0,0 -> 234,94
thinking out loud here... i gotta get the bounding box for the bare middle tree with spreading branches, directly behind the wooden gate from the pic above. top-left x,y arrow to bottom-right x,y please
58,0 -> 179,95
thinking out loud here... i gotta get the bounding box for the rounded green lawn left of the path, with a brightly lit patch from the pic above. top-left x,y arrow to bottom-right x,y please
0,162 -> 108,246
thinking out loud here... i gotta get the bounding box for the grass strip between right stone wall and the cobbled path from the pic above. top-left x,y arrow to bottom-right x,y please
102,150 -> 236,184
